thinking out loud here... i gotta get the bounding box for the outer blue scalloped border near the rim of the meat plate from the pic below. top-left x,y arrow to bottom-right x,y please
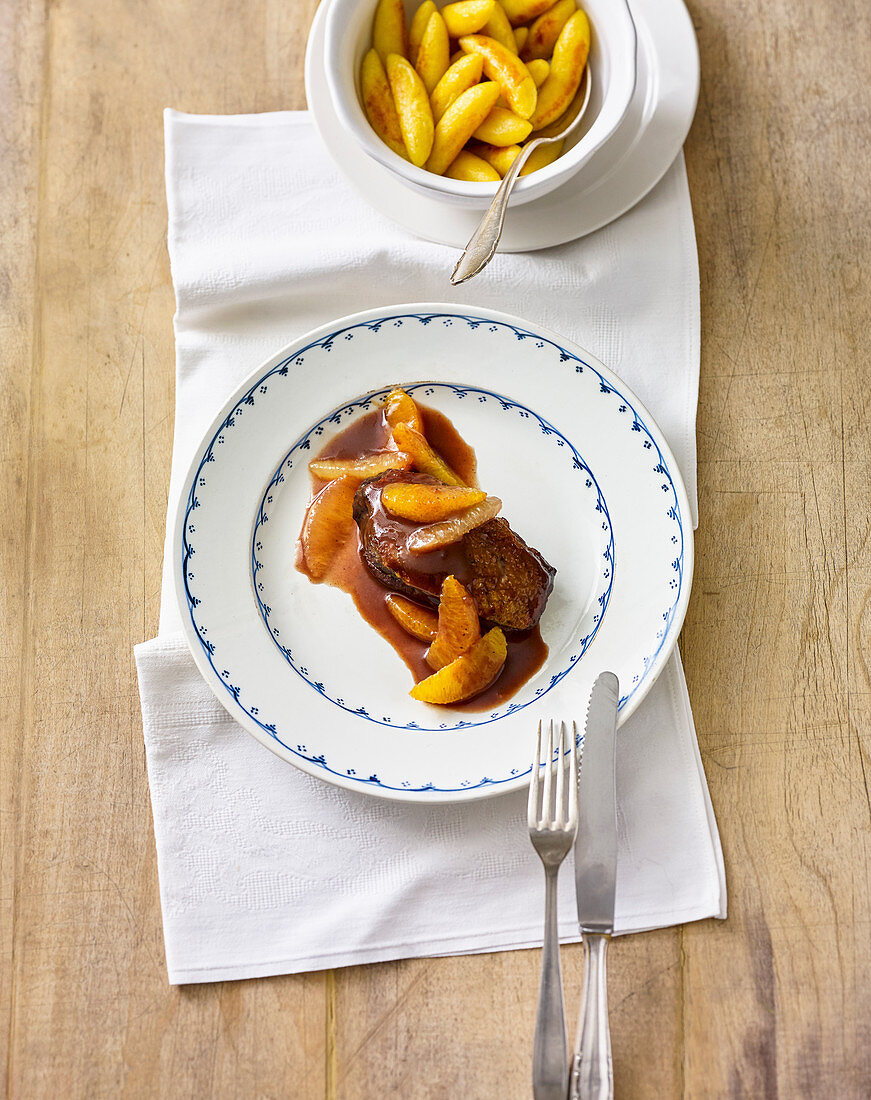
180,311 -> 685,794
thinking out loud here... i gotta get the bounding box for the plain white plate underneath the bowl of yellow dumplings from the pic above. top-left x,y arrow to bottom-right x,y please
306,0 -> 699,252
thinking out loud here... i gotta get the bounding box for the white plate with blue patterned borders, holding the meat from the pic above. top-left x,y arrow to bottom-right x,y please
173,305 -> 693,802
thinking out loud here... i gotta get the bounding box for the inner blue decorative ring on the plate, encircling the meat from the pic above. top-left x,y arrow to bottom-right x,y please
251,382 -> 616,744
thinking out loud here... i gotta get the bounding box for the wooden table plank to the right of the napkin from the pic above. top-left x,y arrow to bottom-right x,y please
682,2 -> 871,1097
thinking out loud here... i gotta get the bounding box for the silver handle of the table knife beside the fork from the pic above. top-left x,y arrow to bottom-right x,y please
569,932 -> 614,1100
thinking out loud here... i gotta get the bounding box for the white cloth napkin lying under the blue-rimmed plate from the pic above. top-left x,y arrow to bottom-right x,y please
136,111 -> 726,983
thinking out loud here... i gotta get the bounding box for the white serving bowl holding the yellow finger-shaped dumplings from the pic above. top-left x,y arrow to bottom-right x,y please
323,0 -> 636,210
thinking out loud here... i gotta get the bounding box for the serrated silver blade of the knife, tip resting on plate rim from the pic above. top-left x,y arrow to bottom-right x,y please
574,672 -> 620,935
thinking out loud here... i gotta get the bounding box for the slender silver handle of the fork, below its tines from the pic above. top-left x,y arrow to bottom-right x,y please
532,866 -> 569,1100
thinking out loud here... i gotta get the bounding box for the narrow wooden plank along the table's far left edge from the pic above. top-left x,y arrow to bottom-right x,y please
0,2 -> 43,1100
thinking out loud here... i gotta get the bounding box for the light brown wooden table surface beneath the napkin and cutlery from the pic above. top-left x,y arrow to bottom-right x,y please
0,0 -> 871,1100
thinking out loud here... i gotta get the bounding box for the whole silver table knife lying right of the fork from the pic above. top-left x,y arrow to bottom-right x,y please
569,672 -> 620,1100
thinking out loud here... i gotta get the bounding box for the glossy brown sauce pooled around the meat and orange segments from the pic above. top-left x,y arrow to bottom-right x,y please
296,403 -> 548,712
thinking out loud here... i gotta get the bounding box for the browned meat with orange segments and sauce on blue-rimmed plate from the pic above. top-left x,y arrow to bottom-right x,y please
297,386 -> 556,708
